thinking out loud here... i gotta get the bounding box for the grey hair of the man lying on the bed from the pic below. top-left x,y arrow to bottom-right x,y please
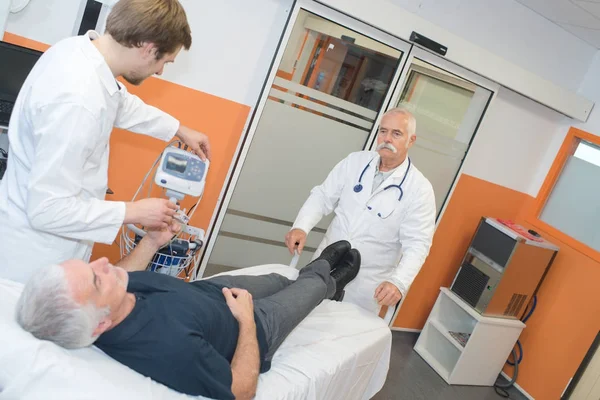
16,265 -> 109,349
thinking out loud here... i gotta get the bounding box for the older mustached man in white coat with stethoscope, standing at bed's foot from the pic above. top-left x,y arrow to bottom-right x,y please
285,108 -> 436,312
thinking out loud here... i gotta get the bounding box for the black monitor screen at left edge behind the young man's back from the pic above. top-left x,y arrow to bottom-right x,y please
0,41 -> 42,101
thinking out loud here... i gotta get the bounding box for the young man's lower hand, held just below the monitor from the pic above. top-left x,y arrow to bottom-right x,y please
123,198 -> 177,230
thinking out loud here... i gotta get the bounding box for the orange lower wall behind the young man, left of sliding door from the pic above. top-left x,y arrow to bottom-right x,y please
3,33 -> 250,262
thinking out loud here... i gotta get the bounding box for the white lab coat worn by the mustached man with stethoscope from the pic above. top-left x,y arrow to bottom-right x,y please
294,151 -> 436,312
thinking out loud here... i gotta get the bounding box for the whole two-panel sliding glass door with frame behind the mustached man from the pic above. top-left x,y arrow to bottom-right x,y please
197,1 -> 497,277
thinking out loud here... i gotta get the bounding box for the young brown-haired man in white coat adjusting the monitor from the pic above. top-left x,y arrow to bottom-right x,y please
0,0 -> 209,282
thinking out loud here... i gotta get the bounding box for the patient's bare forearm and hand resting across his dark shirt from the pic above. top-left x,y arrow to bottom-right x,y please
223,288 -> 260,400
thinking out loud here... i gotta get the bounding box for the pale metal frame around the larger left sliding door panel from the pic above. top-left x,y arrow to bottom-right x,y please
192,0 -> 413,279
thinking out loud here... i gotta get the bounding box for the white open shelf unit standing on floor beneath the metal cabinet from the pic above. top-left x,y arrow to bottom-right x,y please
414,288 -> 525,386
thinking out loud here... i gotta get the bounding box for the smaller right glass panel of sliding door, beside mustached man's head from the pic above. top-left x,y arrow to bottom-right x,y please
398,58 -> 492,214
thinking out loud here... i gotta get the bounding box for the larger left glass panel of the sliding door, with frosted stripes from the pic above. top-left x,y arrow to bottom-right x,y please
203,10 -> 402,276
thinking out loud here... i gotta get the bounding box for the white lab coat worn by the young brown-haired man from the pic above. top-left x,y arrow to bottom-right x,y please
0,32 -> 179,282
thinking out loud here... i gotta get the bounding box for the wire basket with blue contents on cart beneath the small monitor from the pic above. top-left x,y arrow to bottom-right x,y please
119,225 -> 202,279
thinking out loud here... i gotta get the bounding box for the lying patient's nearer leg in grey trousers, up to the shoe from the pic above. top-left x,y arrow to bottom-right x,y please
254,260 -> 336,361
